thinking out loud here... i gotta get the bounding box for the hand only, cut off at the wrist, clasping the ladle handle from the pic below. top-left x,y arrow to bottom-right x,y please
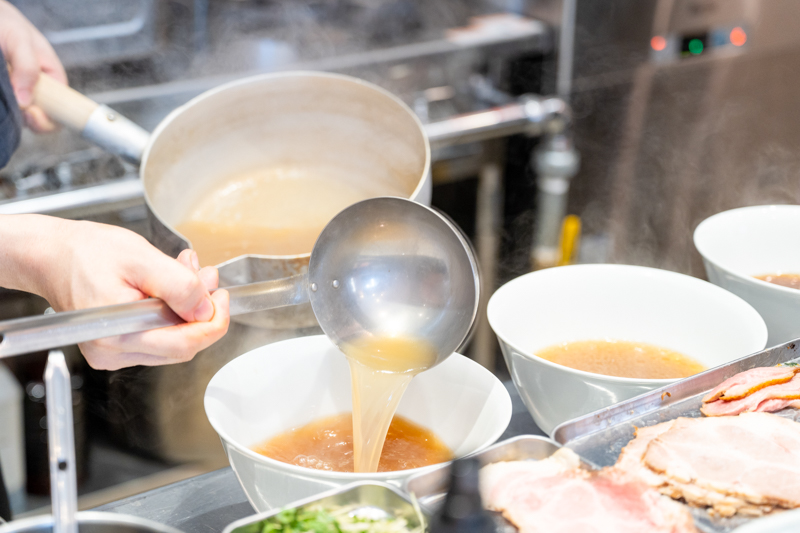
42,221 -> 229,370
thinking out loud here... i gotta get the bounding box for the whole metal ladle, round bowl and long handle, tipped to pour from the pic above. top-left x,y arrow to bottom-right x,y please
0,198 -> 480,368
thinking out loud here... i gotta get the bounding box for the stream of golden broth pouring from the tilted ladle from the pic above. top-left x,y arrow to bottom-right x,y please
340,337 -> 436,472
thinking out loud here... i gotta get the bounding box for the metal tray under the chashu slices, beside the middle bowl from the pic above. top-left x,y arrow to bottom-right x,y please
553,340 -> 800,533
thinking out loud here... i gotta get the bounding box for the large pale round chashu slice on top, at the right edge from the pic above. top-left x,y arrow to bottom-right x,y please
643,413 -> 800,516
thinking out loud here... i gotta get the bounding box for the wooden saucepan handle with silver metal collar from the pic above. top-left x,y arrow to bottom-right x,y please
33,74 -> 150,163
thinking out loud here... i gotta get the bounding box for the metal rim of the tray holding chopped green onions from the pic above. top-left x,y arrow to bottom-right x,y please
223,482 -> 428,533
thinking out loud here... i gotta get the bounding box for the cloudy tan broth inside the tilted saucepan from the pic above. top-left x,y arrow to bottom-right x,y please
175,167 -> 407,266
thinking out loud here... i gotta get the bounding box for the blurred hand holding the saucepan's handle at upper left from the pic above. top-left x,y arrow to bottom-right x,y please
0,0 -> 67,133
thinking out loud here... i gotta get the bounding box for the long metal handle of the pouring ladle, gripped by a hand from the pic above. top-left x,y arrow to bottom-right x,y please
0,274 -> 308,358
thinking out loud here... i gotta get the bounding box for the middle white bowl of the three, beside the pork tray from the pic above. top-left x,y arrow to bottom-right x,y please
488,265 -> 767,434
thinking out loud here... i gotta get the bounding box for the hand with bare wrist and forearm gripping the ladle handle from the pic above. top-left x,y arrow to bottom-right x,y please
0,215 -> 230,370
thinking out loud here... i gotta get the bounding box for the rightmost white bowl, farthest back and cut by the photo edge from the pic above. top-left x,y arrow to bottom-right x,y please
694,205 -> 800,346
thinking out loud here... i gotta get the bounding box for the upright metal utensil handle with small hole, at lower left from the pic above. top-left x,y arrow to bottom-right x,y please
44,350 -> 78,533
